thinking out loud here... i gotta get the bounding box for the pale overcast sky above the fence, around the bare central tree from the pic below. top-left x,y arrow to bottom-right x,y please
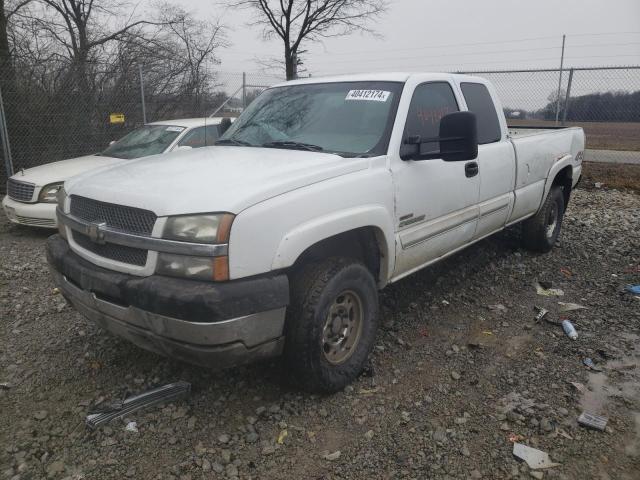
175,0 -> 640,76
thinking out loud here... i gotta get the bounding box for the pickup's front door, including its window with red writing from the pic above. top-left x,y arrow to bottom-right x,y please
391,81 -> 480,279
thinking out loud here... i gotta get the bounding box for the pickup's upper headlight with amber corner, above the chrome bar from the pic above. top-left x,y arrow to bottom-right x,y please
162,213 -> 233,243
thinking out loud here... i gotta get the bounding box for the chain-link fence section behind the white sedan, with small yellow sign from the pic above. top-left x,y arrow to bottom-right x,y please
0,69 -> 282,193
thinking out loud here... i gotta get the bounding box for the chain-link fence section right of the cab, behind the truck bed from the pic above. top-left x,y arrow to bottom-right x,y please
464,66 -> 640,164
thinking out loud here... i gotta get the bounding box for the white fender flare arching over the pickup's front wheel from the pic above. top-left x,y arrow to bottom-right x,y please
271,205 -> 395,285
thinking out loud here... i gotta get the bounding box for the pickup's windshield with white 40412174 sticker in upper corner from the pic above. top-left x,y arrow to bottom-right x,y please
216,82 -> 402,157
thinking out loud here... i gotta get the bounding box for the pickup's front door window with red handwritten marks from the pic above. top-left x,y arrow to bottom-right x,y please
403,82 -> 459,149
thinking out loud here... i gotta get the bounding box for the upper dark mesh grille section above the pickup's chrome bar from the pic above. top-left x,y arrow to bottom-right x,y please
70,195 -> 157,236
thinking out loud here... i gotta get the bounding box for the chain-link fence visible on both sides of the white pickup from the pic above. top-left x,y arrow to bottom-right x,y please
0,66 -> 640,191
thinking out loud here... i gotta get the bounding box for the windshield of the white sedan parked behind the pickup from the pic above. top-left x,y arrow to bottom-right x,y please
100,125 -> 185,159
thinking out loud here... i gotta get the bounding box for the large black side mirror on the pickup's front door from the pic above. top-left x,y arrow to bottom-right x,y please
400,112 -> 478,162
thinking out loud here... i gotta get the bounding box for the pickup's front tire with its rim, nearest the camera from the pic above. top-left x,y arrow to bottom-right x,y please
284,258 -> 378,393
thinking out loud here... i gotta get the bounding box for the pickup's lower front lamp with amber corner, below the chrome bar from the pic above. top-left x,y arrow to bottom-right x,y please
156,253 -> 229,282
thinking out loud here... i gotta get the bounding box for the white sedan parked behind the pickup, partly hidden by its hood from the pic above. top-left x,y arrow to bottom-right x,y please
2,117 -> 230,228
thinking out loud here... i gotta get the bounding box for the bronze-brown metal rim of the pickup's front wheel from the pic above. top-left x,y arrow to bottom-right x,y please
322,290 -> 364,364
